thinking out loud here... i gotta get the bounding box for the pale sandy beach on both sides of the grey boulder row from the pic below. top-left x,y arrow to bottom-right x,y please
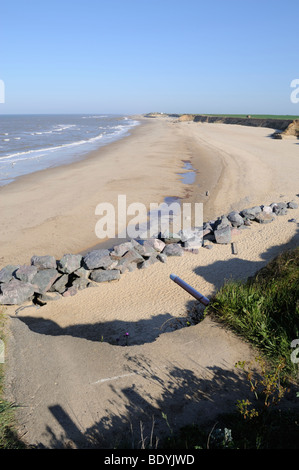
0,116 -> 299,448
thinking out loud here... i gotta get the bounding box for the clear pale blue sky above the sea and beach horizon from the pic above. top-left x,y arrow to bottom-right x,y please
0,0 -> 299,115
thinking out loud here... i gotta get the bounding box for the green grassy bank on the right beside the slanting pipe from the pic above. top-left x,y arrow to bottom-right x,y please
207,247 -> 299,374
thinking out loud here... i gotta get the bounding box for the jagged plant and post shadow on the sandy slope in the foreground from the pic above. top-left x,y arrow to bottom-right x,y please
37,355 -> 258,450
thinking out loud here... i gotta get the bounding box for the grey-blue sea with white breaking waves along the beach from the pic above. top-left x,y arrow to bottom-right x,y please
0,114 -> 140,186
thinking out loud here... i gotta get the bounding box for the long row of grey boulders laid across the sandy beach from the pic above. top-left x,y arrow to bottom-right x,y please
0,196 -> 298,306
